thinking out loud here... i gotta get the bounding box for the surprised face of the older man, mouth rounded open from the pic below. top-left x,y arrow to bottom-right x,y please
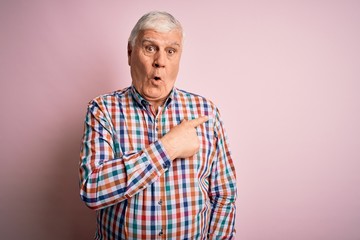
128,30 -> 182,107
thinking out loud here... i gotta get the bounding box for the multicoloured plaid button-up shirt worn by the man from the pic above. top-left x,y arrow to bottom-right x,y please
80,86 -> 236,239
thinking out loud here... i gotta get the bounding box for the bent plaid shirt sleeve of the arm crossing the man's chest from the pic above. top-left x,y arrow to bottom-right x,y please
79,98 -> 171,209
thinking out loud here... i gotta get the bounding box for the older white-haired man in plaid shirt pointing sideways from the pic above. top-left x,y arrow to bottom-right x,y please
80,12 -> 236,239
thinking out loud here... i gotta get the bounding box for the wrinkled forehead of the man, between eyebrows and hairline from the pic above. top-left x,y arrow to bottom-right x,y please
137,29 -> 182,47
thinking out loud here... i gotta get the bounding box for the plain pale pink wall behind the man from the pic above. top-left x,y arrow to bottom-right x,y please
0,0 -> 360,240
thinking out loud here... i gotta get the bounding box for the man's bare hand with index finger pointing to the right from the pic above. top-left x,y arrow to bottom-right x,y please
160,116 -> 208,160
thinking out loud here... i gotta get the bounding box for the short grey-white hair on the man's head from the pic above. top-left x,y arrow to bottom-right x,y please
128,11 -> 184,47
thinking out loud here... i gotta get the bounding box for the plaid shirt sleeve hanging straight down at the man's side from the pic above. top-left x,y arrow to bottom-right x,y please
208,108 -> 237,239
